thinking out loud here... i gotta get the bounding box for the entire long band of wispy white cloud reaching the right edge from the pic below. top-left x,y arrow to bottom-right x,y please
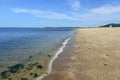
11,5 -> 120,24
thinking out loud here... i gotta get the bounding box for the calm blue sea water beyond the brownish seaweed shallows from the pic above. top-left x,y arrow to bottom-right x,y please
0,28 -> 74,68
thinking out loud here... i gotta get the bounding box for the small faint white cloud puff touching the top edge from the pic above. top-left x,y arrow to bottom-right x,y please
68,0 -> 81,10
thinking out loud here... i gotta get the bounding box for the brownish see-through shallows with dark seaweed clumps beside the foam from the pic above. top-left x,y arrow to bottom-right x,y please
1,38 -> 69,80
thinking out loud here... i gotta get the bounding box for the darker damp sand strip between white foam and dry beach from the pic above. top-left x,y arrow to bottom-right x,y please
42,30 -> 76,80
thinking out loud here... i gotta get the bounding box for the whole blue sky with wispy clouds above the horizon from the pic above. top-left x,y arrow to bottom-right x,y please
0,0 -> 120,27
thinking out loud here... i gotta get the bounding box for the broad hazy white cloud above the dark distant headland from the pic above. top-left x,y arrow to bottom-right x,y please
80,5 -> 120,22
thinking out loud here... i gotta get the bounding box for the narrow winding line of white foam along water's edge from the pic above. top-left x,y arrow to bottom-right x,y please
36,38 -> 70,80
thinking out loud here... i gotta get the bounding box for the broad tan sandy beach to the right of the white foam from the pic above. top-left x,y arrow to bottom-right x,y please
43,28 -> 120,80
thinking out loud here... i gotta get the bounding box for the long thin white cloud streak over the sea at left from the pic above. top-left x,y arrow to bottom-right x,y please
11,8 -> 74,20
